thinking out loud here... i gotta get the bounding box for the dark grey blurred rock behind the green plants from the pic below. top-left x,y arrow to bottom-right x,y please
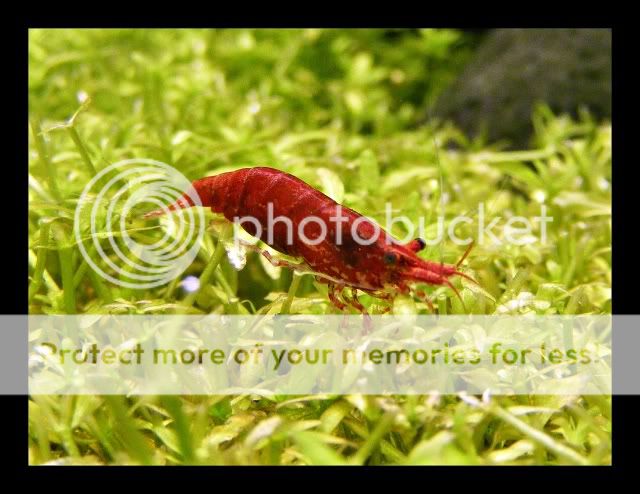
433,29 -> 611,146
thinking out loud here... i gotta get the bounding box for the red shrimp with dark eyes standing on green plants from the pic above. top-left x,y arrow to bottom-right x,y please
145,167 -> 476,314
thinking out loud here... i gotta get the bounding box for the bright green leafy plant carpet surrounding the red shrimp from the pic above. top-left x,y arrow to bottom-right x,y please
29,29 -> 611,465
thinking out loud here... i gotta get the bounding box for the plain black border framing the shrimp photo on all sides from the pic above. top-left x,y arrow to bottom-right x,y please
6,18 -> 640,482
